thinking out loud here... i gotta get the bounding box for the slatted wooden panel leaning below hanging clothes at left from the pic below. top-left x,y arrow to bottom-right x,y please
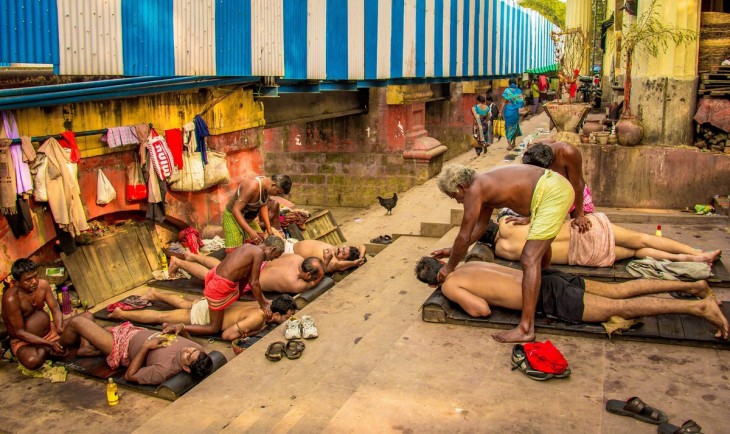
61,223 -> 161,306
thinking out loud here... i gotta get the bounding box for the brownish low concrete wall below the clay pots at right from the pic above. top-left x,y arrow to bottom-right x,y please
579,145 -> 730,209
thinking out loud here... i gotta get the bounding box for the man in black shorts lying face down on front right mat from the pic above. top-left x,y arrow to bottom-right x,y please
415,257 -> 730,339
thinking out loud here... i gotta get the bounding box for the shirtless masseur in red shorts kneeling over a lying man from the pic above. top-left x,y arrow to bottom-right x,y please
171,235 -> 284,335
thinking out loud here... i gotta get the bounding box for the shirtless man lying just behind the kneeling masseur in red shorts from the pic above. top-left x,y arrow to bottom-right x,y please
169,251 -> 322,294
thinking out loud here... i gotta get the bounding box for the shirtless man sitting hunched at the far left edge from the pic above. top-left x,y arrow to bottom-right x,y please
2,259 -> 65,369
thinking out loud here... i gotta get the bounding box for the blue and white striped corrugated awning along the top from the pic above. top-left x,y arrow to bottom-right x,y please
0,0 -> 554,81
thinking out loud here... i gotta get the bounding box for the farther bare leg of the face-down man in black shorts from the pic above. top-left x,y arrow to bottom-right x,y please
585,279 -> 714,299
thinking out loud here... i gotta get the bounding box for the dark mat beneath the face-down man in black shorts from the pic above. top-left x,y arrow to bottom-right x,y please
422,289 -> 730,350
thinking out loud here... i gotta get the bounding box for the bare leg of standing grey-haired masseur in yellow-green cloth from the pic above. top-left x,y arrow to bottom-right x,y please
493,238 -> 553,342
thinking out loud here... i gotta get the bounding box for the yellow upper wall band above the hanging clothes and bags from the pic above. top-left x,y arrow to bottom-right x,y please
13,88 -> 265,158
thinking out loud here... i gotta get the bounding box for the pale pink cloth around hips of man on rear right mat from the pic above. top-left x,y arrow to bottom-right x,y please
568,212 -> 616,267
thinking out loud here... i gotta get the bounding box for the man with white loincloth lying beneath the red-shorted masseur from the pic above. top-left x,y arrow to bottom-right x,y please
109,289 -> 297,340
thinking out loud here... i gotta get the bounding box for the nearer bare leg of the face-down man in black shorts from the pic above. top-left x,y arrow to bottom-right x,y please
583,293 -> 730,339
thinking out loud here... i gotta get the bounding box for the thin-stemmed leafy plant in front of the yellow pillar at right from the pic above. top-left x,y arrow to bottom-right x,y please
622,0 -> 697,116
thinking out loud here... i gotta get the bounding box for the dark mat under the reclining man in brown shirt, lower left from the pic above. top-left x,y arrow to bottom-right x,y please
56,351 -> 227,401
